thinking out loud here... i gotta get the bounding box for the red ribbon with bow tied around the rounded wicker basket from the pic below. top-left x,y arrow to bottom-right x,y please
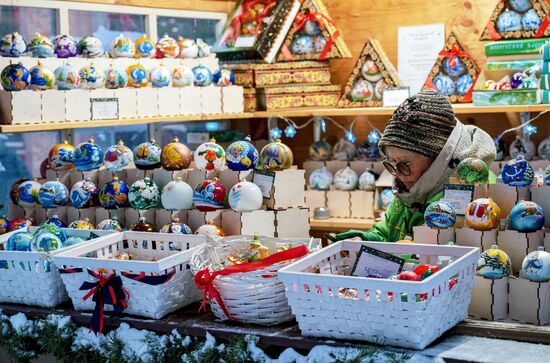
195,245 -> 309,319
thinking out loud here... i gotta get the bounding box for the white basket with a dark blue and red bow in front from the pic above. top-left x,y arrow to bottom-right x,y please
54,232 -> 207,319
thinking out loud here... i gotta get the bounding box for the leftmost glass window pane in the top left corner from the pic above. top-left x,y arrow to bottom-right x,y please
0,5 -> 57,41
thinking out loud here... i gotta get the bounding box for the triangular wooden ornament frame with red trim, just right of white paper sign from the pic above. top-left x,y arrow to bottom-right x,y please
424,32 -> 480,103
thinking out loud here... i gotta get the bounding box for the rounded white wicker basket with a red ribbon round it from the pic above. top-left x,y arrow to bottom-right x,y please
191,236 -> 321,325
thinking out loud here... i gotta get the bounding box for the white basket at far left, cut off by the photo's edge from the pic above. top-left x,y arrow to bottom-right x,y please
0,227 -> 115,308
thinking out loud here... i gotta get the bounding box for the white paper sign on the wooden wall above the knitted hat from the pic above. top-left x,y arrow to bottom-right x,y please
397,24 -> 445,95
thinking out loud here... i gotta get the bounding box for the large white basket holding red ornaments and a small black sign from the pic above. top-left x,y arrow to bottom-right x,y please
279,241 -> 479,349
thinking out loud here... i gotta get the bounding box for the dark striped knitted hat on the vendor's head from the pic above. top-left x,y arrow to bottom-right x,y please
379,90 -> 456,159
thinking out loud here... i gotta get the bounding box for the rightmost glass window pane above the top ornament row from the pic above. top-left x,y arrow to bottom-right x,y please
157,16 -> 220,44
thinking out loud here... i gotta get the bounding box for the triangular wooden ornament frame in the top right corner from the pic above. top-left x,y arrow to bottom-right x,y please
479,0 -> 550,41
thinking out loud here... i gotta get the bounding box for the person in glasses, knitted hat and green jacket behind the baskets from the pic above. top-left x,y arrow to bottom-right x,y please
336,90 -> 496,242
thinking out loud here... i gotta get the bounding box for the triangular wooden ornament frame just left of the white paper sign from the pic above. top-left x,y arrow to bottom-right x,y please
338,39 -> 404,107
